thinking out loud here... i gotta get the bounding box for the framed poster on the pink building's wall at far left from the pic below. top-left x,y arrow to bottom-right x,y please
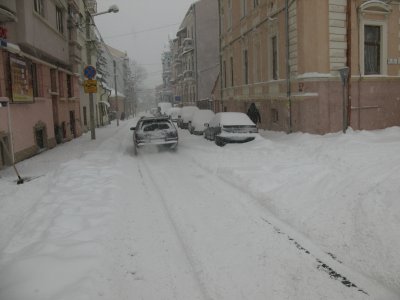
10,57 -> 33,102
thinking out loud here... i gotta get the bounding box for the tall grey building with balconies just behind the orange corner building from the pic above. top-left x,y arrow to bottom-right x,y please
171,0 -> 219,107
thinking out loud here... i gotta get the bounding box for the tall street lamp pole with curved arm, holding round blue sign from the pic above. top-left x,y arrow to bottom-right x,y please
86,5 -> 119,140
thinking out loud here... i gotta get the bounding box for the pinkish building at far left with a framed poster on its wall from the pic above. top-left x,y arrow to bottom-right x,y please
0,0 -> 81,163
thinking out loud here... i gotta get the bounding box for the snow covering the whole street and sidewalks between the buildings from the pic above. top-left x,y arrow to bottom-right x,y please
0,119 -> 400,300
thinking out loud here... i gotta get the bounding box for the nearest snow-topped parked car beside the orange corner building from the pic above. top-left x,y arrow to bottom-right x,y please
204,112 -> 258,146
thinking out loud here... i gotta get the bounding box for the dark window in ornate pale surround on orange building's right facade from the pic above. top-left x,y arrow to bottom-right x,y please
364,25 -> 381,75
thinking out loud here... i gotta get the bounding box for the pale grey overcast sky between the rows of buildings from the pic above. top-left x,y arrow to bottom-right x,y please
95,0 -> 195,88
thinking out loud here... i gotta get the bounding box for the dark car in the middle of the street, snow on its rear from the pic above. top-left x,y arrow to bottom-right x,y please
131,117 -> 178,154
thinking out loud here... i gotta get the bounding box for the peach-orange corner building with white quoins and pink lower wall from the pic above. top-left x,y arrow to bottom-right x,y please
219,0 -> 400,134
